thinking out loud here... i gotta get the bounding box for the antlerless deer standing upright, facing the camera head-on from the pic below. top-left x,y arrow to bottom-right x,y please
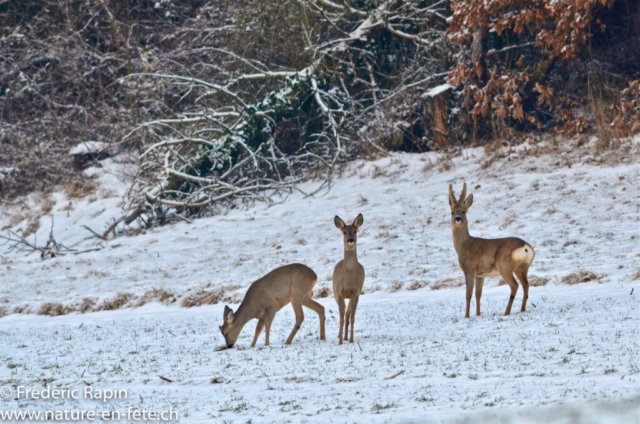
333,214 -> 364,344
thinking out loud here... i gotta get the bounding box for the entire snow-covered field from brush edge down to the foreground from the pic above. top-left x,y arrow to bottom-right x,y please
0,142 -> 640,422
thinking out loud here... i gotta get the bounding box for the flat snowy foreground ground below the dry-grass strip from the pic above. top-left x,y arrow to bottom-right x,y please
0,283 -> 640,422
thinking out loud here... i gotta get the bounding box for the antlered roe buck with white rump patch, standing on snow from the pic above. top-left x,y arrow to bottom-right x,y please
449,183 -> 536,318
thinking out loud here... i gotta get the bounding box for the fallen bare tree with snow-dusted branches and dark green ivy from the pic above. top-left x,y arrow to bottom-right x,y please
104,0 -> 451,237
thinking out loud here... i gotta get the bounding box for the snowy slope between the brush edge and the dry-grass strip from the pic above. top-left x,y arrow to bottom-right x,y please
0,144 -> 640,312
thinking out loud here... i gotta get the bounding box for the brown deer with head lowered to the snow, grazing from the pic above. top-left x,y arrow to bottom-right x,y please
220,264 -> 325,348
